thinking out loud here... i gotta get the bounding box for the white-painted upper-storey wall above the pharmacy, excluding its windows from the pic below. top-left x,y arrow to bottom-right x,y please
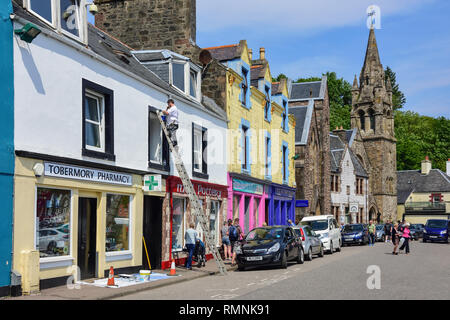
14,23 -> 227,185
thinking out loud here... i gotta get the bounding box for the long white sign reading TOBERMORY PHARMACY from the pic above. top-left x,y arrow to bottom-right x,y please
44,162 -> 133,186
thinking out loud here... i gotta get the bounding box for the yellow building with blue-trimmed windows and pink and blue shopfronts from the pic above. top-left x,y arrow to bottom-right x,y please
205,40 -> 295,232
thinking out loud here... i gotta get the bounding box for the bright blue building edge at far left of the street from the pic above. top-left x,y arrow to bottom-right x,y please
0,0 -> 14,296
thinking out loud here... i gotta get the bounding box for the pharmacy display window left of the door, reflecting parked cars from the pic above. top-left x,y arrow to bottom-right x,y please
36,188 -> 71,258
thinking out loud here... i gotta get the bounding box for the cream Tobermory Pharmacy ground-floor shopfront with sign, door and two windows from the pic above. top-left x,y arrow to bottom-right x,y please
13,157 -> 143,293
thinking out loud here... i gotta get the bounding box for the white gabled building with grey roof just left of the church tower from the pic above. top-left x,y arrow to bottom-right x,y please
330,134 -> 369,224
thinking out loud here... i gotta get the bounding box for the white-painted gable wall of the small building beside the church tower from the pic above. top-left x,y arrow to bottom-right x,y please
331,149 -> 367,223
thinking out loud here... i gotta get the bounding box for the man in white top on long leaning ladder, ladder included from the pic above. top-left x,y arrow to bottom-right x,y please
158,99 -> 227,274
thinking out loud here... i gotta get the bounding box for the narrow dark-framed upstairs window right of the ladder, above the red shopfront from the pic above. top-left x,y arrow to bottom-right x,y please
192,123 -> 208,179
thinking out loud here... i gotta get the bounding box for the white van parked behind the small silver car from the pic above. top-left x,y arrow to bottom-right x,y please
300,215 -> 342,254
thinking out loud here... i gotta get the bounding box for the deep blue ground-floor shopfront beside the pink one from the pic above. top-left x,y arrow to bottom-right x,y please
268,184 -> 295,226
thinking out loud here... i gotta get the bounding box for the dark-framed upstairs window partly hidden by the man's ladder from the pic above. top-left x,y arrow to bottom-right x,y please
148,107 -> 170,171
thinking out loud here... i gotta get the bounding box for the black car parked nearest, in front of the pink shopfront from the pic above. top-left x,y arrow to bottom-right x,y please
236,226 -> 305,271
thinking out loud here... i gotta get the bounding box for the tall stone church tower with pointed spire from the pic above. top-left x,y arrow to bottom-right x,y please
351,28 -> 397,221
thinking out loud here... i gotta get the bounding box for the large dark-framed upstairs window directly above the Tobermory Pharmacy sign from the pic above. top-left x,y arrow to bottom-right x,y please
82,79 -> 115,161
